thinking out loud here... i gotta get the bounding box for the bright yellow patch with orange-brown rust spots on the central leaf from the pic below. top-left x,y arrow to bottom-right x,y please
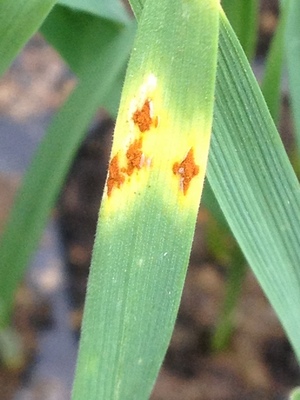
102,73 -> 210,216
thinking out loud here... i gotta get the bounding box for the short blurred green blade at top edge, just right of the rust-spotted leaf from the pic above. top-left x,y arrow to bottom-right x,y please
222,0 -> 259,60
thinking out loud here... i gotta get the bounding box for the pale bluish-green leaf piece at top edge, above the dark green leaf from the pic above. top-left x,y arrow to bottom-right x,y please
58,0 -> 129,24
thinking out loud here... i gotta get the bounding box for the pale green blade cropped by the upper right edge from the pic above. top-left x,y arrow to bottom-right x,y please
284,0 -> 300,153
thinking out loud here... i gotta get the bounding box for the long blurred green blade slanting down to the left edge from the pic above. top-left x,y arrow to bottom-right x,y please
0,24 -> 135,326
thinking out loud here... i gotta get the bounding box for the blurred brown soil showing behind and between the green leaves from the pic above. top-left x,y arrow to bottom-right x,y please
0,0 -> 300,400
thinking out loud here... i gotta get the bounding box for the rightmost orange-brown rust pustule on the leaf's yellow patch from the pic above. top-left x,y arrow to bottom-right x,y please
172,148 -> 199,194
